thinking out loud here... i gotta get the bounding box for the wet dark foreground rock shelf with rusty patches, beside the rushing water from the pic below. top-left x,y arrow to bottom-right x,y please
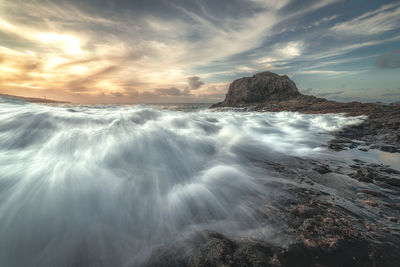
143,155 -> 400,266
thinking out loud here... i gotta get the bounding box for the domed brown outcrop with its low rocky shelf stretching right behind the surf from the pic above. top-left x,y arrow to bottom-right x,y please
210,72 -> 400,153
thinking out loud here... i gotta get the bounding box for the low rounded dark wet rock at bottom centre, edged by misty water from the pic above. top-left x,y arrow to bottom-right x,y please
142,231 -> 280,267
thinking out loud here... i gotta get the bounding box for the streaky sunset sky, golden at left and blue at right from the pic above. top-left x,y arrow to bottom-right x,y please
0,0 -> 400,103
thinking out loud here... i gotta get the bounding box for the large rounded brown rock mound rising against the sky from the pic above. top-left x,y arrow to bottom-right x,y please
213,71 -> 301,107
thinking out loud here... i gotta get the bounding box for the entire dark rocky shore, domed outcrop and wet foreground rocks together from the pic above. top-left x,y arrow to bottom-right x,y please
143,72 -> 400,267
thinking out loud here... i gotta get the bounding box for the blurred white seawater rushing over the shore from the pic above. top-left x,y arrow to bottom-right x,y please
0,98 -> 362,267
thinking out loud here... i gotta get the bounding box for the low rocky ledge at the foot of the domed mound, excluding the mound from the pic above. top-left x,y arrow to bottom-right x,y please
210,96 -> 400,153
